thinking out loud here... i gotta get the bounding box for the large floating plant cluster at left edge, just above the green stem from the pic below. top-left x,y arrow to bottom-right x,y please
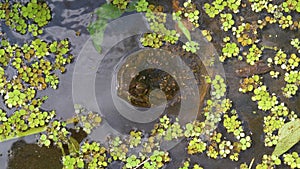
0,32 -> 73,143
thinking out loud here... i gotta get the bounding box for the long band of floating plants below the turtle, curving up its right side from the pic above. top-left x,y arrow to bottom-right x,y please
40,75 -> 252,169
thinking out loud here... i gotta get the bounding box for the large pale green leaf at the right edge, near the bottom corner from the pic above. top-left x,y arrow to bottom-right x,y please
272,119 -> 300,157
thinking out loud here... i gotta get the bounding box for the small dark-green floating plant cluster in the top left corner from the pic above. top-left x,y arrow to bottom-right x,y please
0,0 -> 52,36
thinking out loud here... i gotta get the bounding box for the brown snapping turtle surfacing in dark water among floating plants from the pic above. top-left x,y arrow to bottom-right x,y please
116,45 -> 208,113
